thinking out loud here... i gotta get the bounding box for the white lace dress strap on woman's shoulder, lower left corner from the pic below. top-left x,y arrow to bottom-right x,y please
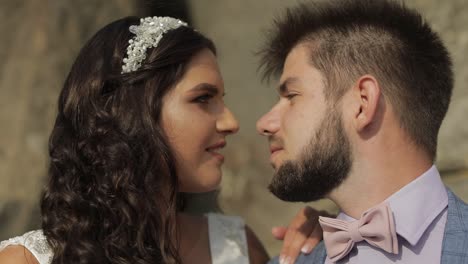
0,230 -> 53,264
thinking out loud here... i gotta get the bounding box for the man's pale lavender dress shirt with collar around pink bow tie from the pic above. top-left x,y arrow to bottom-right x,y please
325,166 -> 448,264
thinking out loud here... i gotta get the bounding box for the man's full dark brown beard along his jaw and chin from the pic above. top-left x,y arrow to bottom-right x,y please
268,110 -> 352,202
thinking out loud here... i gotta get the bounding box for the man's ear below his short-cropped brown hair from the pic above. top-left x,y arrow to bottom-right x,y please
352,75 -> 381,132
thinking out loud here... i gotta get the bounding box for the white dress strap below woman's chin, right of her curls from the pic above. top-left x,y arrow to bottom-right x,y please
207,213 -> 249,264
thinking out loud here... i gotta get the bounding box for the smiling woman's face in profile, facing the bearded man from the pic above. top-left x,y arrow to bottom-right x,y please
162,49 -> 239,193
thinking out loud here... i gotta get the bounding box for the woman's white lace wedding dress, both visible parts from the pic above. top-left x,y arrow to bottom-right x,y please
0,213 -> 249,264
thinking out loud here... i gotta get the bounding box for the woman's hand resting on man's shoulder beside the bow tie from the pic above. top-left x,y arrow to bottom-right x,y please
272,206 -> 331,263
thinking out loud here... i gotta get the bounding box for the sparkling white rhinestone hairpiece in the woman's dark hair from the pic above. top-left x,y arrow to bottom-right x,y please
122,16 -> 187,73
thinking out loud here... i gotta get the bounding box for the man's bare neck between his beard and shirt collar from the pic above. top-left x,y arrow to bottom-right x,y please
329,138 -> 432,219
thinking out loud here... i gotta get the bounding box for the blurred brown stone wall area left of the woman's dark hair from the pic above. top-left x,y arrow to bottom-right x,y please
0,0 -> 139,239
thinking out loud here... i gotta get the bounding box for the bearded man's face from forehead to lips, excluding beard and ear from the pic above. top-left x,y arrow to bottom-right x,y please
257,45 -> 327,170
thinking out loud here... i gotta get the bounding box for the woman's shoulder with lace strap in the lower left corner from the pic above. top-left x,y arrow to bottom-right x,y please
0,230 -> 52,264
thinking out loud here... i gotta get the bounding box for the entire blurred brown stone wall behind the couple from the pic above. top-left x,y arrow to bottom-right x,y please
0,0 -> 468,255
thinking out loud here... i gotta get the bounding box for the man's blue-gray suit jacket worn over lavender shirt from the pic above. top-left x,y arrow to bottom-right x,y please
268,189 -> 468,264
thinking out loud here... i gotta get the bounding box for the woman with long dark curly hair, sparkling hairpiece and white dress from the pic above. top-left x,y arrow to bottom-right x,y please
0,17 -> 322,264
